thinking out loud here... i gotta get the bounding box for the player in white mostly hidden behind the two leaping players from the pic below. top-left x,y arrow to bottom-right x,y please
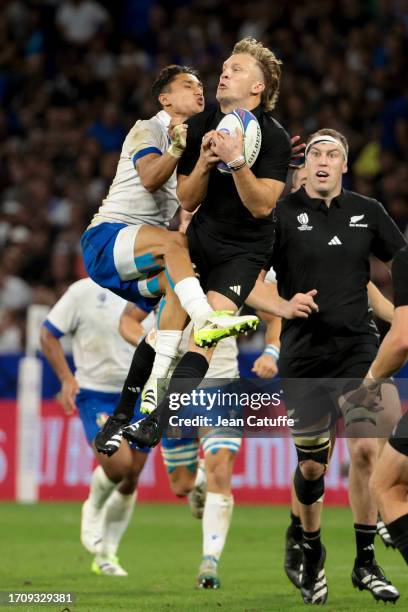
122,298 -> 280,589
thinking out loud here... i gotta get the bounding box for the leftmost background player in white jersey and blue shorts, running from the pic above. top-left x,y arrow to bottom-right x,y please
41,278 -> 154,576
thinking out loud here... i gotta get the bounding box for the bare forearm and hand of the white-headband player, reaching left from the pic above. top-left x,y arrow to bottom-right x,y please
245,278 -> 319,319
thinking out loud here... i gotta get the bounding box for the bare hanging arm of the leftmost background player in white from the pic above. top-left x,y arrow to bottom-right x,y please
40,326 -> 79,414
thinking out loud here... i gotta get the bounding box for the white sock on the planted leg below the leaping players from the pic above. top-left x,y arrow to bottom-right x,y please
203,492 -> 234,561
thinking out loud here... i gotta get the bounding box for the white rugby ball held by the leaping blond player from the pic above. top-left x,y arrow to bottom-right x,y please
216,108 -> 262,174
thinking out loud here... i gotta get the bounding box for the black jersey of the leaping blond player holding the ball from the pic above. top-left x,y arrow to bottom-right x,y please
177,106 -> 291,242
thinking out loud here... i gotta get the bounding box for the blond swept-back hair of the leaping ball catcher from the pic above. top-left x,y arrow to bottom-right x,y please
232,36 -> 282,111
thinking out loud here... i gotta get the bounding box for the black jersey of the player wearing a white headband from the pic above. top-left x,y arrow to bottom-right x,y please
270,188 -> 405,357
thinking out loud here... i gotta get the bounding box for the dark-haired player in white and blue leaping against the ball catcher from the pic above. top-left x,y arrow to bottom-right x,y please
81,65 -> 257,447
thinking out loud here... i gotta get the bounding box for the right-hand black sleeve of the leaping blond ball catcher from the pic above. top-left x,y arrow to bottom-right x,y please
256,124 -> 292,183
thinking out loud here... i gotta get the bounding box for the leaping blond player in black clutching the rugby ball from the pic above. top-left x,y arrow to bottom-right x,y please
125,39 -> 291,446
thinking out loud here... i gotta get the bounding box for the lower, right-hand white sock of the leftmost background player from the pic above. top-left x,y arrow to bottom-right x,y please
98,490 -> 136,557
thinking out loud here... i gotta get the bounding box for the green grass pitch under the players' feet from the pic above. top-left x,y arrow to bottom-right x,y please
0,503 -> 408,612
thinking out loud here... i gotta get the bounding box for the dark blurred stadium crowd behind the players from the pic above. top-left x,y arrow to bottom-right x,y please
0,0 -> 408,352
